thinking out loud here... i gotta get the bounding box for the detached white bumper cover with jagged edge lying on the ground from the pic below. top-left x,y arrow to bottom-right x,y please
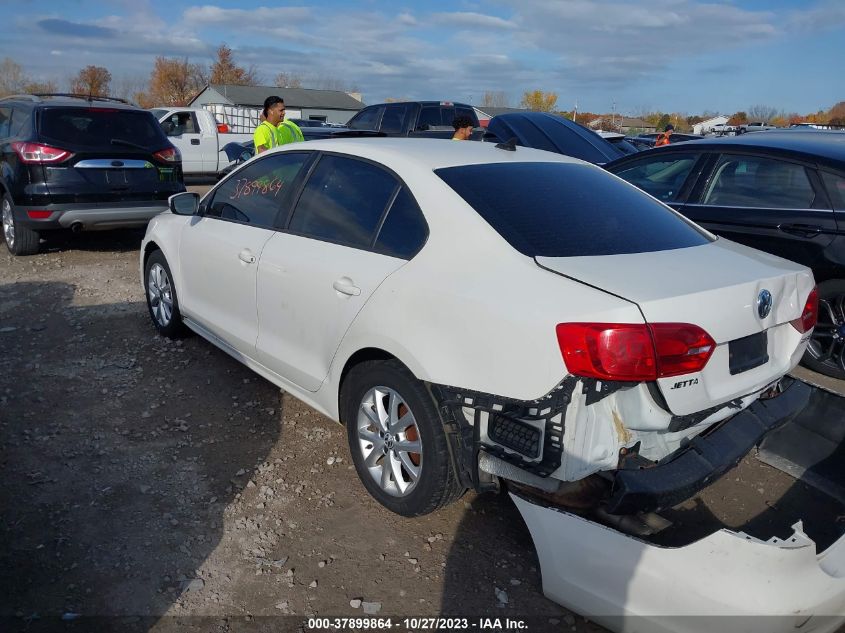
511,493 -> 845,633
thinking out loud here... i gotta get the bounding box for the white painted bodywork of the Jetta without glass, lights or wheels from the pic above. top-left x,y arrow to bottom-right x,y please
145,139 -> 812,480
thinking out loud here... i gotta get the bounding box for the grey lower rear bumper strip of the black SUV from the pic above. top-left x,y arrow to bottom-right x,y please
15,200 -> 168,231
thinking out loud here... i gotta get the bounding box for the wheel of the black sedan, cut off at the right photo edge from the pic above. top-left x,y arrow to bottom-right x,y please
801,279 -> 845,379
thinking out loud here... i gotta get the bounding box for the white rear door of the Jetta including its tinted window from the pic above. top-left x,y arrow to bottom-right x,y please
258,154 -> 418,391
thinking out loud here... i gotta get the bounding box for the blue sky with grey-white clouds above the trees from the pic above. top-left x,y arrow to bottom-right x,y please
0,0 -> 845,114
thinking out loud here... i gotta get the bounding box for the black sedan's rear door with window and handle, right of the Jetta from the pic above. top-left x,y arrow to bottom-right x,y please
682,153 -> 836,268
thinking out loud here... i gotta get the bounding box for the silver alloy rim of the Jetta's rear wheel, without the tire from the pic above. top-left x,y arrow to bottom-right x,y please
357,387 -> 423,497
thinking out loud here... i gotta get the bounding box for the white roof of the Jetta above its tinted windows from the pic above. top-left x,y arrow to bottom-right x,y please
262,137 -> 586,170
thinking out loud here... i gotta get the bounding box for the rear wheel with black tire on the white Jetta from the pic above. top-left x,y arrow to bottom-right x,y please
340,360 -> 465,517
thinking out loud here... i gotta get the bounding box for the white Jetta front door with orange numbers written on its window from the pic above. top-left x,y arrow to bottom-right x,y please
179,152 -> 311,357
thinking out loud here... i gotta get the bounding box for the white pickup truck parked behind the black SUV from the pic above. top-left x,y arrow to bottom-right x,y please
150,107 -> 252,176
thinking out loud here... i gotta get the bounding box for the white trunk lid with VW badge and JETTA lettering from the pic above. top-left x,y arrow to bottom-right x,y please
535,238 -> 814,415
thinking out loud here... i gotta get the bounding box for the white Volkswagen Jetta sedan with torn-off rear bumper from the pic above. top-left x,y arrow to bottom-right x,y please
141,139 -> 817,516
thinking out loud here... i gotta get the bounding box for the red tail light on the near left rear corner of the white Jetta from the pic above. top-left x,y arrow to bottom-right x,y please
556,323 -> 716,381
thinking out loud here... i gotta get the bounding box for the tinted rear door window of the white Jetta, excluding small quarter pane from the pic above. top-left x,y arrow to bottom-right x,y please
289,156 -> 398,248
